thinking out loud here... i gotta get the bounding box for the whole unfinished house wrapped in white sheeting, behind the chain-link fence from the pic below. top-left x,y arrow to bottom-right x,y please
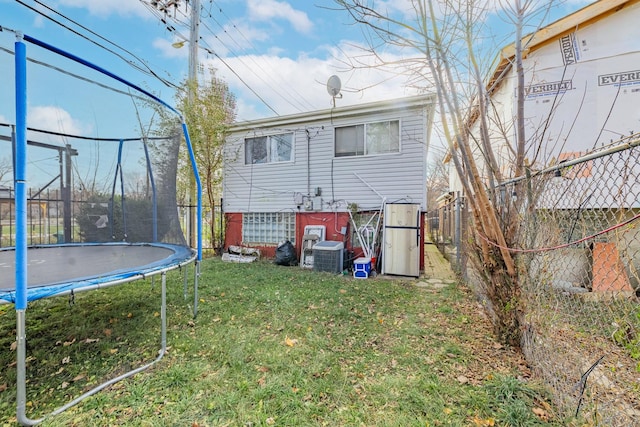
450,0 -> 640,290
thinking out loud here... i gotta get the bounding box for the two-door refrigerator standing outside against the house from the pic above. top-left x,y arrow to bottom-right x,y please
382,203 -> 420,277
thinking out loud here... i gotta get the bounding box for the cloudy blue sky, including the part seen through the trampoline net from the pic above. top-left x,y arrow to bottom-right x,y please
0,0 -> 589,188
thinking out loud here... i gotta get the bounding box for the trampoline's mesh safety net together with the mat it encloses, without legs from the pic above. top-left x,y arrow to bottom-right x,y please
0,32 -> 197,302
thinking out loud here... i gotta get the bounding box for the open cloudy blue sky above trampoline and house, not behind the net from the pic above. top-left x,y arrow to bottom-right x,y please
0,0 -> 588,126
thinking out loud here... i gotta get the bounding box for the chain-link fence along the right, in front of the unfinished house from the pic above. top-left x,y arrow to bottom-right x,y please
428,138 -> 640,426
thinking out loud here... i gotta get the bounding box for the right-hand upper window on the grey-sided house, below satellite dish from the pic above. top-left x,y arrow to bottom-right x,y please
335,120 -> 400,157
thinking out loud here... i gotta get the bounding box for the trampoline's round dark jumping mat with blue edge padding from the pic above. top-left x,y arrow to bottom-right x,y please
0,243 -> 195,304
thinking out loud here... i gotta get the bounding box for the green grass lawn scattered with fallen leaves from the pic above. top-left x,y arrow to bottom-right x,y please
0,258 -> 566,426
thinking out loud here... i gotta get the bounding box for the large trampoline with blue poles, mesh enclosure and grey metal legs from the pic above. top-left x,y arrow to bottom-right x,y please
0,27 -> 202,425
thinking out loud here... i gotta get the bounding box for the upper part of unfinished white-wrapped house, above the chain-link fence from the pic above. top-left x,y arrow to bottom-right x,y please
450,0 -> 640,197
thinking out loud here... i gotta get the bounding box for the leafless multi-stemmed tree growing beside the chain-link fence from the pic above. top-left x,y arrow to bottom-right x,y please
335,0 -> 549,345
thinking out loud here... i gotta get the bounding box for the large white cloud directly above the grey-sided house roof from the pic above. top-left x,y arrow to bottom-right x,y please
208,42 -> 417,121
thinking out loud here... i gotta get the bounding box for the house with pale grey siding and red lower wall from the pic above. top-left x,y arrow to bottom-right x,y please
223,96 -> 434,272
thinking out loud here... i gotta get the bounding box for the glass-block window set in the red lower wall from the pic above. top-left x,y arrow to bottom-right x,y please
242,212 -> 296,245
